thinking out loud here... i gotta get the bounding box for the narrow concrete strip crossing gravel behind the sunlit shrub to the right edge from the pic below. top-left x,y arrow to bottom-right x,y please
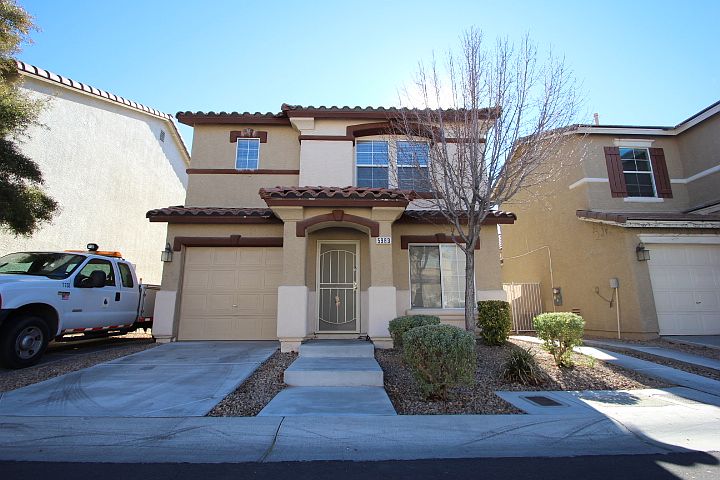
512,335 -> 720,396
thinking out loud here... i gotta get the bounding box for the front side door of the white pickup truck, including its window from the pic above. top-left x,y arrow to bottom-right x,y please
62,258 -> 122,329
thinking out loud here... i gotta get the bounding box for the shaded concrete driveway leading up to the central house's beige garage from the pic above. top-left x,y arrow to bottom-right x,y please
0,342 -> 279,417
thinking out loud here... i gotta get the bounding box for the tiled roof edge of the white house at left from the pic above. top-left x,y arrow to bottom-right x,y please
16,60 -> 190,164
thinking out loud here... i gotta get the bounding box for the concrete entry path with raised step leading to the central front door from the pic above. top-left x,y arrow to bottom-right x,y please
258,340 -> 396,417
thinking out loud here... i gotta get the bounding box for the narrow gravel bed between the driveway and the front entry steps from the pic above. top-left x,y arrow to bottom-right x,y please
208,350 -> 297,417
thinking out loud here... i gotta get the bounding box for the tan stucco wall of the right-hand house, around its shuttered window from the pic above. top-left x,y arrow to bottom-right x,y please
502,136 -> 708,338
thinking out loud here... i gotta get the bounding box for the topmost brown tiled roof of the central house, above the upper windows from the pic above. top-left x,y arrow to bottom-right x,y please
176,103 -> 498,126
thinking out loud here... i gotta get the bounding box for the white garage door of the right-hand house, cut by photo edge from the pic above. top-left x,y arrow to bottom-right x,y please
648,244 -> 720,335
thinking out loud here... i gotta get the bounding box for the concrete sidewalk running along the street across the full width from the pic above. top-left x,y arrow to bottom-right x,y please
0,392 -> 720,463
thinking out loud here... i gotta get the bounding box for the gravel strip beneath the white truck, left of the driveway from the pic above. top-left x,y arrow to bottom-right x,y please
0,334 -> 155,392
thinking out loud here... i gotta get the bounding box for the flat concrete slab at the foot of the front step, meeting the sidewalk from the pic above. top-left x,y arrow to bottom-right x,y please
258,387 -> 396,417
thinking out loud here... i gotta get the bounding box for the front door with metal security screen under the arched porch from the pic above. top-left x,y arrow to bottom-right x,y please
317,241 -> 360,333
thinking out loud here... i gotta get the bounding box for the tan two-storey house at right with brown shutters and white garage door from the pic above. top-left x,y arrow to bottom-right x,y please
503,98 -> 720,339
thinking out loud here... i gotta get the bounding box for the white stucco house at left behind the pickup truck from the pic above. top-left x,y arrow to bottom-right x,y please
0,62 -> 190,283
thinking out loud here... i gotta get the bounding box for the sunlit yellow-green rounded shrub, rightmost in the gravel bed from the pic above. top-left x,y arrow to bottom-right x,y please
533,312 -> 585,367
